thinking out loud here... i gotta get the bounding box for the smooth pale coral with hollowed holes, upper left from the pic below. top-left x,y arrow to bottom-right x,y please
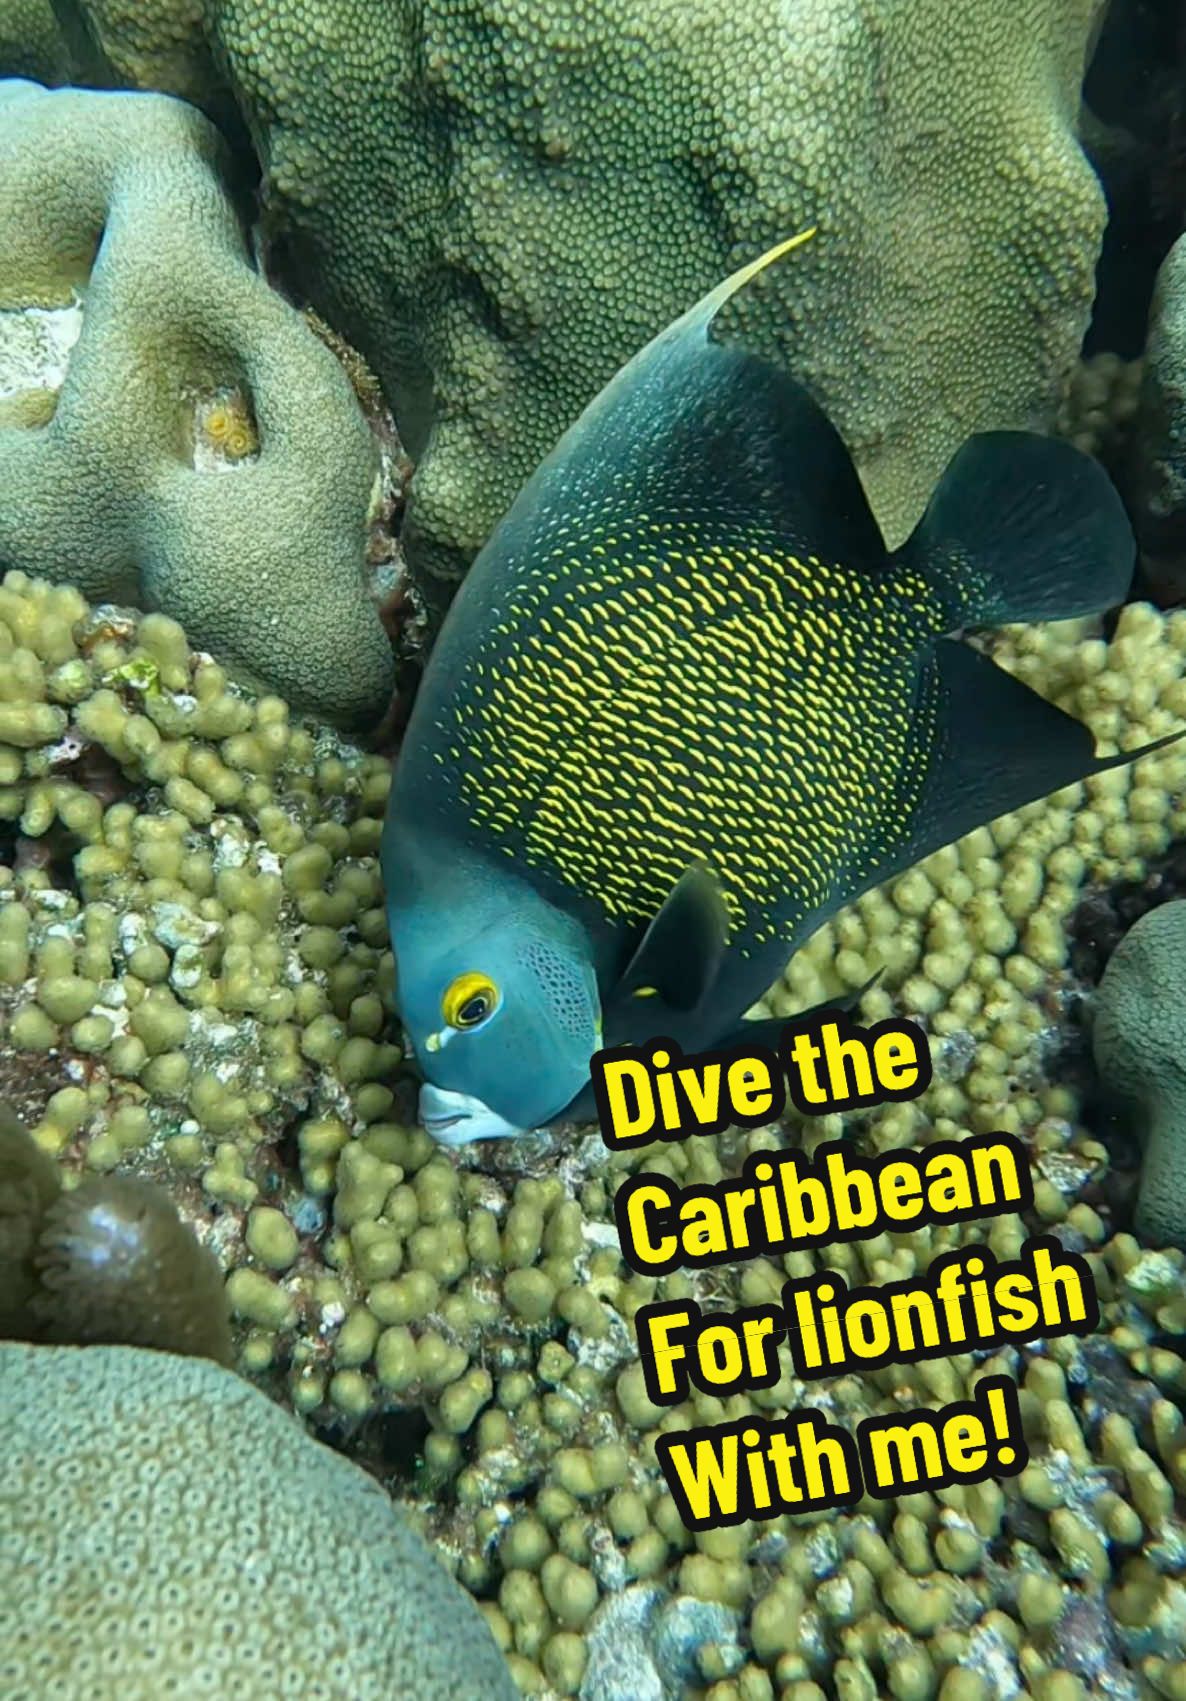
0,82 -> 395,726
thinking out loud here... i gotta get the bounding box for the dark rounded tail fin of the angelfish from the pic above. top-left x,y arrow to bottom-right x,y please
893,430 -> 1137,631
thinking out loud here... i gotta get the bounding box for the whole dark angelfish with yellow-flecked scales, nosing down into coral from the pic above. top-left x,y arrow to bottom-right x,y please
381,231 -> 1154,1145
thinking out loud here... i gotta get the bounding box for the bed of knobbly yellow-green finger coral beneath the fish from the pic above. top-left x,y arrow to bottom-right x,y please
0,573 -> 1186,1701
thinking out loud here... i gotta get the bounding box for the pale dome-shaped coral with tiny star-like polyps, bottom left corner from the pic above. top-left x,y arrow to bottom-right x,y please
0,1344 -> 516,1701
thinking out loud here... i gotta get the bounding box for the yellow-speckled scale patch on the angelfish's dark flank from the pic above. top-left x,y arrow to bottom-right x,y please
436,505 -> 939,944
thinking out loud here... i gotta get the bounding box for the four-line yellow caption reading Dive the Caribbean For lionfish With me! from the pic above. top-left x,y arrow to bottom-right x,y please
592,1010 -> 1099,1529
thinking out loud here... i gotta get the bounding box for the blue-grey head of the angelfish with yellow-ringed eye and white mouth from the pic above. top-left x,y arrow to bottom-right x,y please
391,902 -> 602,1146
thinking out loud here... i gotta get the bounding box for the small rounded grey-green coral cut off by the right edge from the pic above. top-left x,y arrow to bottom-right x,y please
1094,900 -> 1186,1249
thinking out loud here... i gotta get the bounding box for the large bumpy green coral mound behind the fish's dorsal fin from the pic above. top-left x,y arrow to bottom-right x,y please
0,0 -> 1104,598
